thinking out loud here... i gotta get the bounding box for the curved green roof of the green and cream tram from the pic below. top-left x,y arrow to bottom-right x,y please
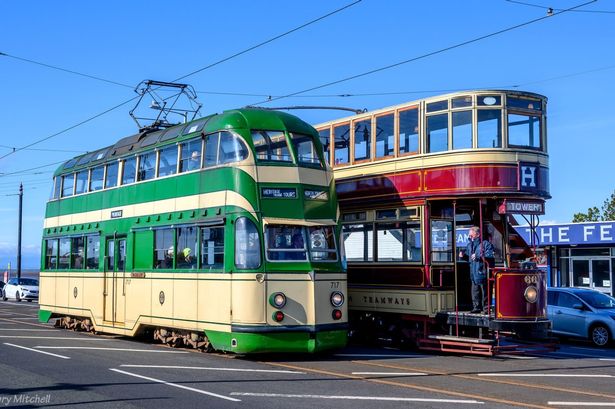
54,108 -> 313,176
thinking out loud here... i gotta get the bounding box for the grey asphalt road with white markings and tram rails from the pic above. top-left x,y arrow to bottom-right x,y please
0,301 -> 615,409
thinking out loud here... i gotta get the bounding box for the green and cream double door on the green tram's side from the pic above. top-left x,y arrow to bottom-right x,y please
103,237 -> 126,325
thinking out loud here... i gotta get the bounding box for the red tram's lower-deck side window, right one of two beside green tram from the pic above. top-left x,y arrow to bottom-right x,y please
376,222 -> 421,261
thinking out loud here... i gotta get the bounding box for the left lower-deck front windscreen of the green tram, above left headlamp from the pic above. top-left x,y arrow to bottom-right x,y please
265,225 -> 307,261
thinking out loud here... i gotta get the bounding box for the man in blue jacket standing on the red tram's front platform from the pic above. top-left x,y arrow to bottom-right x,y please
459,226 -> 494,313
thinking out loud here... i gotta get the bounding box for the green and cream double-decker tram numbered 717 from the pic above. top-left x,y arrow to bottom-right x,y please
39,109 -> 347,353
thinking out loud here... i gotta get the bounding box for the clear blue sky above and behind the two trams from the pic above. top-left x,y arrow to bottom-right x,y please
0,0 -> 615,269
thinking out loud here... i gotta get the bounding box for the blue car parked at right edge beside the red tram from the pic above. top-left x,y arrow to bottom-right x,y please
547,287 -> 615,347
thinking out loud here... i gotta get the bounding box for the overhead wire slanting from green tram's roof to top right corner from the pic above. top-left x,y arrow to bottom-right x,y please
250,0 -> 597,106
